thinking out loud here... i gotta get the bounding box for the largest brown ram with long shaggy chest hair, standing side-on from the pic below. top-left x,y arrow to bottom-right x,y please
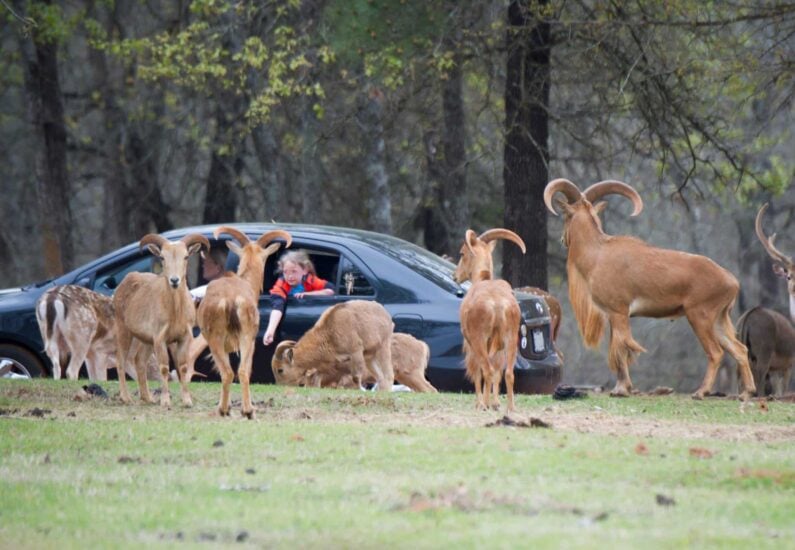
544,179 -> 755,399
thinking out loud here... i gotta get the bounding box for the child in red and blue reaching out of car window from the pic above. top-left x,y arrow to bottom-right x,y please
262,250 -> 334,346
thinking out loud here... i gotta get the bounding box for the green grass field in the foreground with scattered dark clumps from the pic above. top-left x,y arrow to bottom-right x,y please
0,380 -> 795,549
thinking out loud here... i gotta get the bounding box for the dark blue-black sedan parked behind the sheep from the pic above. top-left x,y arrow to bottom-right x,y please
0,224 -> 561,393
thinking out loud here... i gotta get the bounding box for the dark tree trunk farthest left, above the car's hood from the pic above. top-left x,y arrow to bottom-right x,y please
15,1 -> 74,277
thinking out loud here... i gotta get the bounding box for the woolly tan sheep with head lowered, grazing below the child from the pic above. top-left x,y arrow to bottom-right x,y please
271,300 -> 395,391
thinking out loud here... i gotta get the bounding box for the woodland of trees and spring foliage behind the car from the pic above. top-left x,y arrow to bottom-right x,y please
0,0 -> 795,391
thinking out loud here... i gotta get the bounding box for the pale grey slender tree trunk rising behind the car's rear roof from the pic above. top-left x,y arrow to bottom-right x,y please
359,86 -> 392,234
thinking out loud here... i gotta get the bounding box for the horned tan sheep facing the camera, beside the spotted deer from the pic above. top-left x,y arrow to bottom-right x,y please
113,233 -> 210,407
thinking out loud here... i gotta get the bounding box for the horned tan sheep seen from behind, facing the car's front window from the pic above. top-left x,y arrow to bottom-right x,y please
198,226 -> 292,419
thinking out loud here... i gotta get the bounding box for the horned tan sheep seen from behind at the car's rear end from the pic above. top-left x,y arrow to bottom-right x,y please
453,229 -> 525,412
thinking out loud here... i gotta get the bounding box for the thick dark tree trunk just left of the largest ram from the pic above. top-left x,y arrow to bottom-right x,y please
502,0 -> 551,288
